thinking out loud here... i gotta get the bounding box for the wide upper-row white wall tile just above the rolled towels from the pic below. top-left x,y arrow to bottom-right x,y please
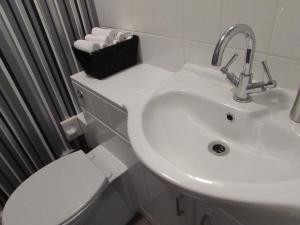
95,0 -> 183,38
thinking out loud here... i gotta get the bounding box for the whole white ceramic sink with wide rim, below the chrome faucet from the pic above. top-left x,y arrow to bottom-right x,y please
126,65 -> 300,209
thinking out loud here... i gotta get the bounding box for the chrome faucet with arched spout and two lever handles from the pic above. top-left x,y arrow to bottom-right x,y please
211,24 -> 277,102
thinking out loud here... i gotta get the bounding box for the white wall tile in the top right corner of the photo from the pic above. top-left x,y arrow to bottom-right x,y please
270,0 -> 300,59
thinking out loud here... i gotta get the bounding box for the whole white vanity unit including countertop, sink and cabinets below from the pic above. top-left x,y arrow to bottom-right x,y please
72,64 -> 300,225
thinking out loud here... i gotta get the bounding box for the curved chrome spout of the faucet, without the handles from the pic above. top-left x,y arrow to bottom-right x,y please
211,24 -> 256,75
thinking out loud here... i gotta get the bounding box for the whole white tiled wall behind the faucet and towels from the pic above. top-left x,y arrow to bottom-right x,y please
95,0 -> 300,90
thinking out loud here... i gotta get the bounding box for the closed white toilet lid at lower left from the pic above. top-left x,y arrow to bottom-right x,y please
3,151 -> 107,225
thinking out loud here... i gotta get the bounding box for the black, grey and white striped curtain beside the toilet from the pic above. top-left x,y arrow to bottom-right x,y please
0,0 -> 98,207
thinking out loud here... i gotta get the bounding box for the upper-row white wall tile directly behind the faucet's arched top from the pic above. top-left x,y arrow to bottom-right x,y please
222,0 -> 277,53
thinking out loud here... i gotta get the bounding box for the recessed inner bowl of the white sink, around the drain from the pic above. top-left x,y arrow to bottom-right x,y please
142,92 -> 300,183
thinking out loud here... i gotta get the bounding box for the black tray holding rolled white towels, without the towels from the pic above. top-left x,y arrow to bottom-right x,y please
72,35 -> 139,79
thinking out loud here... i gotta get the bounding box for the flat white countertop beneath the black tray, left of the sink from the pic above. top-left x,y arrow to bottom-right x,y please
71,64 -> 174,107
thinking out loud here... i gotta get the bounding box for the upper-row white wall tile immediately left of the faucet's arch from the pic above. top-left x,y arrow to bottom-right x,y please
183,0 -> 222,43
